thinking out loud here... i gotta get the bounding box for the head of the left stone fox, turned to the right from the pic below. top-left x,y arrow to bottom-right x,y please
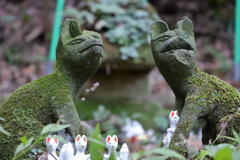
55,19 -> 103,79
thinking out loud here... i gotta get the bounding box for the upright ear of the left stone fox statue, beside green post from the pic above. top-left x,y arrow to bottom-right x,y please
61,19 -> 82,43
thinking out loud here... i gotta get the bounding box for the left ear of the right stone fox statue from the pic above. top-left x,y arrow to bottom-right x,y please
150,20 -> 169,39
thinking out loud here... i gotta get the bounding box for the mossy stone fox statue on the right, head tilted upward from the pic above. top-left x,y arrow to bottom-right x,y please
150,17 -> 240,155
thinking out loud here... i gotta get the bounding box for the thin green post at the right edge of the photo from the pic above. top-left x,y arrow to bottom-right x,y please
234,0 -> 240,81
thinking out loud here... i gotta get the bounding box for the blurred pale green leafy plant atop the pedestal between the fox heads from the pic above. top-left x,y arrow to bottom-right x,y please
62,0 -> 159,60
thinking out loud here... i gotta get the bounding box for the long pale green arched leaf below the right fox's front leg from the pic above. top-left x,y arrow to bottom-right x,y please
145,148 -> 186,160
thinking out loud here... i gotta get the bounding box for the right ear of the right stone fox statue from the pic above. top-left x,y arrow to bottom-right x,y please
176,17 -> 193,35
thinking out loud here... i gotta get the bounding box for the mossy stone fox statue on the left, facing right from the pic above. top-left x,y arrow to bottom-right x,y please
0,19 -> 103,160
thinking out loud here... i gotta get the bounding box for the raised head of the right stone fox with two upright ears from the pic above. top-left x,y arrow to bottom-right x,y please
150,17 -> 197,78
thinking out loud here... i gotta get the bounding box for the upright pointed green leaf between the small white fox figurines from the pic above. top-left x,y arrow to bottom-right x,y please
89,123 -> 104,160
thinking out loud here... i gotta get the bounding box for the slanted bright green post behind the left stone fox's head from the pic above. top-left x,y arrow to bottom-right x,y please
46,0 -> 64,74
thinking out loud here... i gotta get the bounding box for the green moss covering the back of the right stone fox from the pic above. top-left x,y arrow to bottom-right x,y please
188,70 -> 240,143
